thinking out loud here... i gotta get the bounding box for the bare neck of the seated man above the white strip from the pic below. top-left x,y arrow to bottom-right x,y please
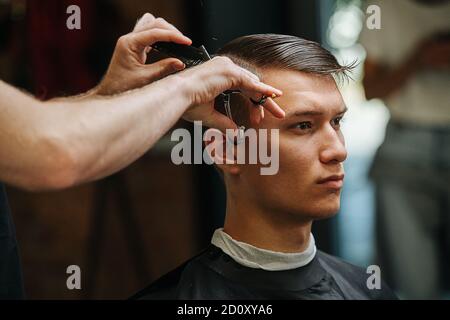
224,191 -> 312,253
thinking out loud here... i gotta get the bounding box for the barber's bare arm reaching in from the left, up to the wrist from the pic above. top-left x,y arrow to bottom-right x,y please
0,76 -> 190,191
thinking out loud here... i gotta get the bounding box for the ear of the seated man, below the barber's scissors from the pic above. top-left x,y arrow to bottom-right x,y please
204,129 -> 240,175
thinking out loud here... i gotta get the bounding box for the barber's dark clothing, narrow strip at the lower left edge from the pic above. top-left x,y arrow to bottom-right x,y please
0,183 -> 24,300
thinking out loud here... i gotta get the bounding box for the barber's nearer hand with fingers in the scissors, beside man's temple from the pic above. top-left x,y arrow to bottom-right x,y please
179,57 -> 285,132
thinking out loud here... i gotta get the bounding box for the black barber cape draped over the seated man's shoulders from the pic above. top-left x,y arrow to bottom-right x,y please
132,245 -> 397,300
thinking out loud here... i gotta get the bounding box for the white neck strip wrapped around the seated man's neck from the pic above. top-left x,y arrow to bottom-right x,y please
211,228 -> 317,271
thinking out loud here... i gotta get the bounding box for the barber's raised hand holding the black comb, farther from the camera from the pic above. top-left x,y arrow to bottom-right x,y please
95,13 -> 192,95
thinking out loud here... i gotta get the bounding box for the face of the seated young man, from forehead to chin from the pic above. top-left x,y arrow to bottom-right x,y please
240,70 -> 347,220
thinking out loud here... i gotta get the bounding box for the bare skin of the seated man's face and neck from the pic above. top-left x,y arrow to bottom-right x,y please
210,70 -> 347,252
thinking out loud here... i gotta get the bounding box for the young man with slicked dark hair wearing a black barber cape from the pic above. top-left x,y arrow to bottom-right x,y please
135,34 -> 395,299
